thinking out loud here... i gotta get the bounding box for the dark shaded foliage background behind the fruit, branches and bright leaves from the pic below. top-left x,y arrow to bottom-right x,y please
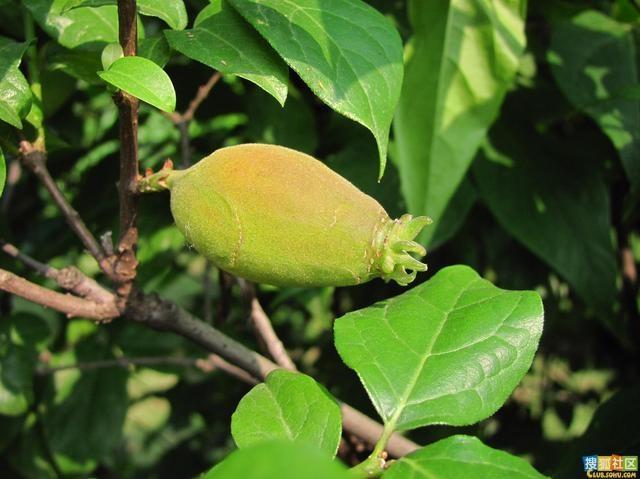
0,0 -> 640,478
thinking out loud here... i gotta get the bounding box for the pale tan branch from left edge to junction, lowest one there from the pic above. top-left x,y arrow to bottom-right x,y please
0,269 -> 120,321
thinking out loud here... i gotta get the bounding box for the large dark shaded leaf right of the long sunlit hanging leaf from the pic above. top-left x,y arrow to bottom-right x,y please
473,122 -> 617,314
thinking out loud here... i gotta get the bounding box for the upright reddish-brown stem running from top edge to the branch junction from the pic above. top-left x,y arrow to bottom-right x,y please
113,0 -> 138,305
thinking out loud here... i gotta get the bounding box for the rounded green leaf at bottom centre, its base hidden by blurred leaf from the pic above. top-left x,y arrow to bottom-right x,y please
231,370 -> 342,456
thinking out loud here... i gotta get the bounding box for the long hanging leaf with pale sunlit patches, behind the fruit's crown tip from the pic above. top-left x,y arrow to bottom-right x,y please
394,0 -> 525,244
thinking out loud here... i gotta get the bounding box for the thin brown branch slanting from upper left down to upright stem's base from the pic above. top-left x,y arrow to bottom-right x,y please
20,141 -> 107,270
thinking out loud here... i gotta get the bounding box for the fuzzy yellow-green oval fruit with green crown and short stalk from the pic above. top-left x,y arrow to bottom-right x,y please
139,144 -> 430,286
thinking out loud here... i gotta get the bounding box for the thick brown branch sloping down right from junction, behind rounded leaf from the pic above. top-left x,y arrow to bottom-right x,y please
125,292 -> 420,457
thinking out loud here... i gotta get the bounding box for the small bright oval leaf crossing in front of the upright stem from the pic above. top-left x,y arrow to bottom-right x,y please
98,57 -> 176,112
